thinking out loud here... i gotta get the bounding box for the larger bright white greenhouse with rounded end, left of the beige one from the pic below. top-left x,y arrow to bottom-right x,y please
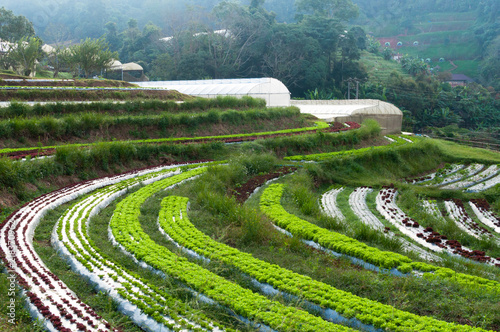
135,77 -> 290,106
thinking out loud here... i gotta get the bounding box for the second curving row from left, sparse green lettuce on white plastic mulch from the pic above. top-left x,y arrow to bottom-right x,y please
53,165 -> 226,331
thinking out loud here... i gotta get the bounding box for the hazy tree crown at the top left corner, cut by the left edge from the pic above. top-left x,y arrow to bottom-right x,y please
0,7 -> 35,42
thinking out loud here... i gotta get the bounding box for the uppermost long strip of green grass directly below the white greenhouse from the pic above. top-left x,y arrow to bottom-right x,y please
0,96 -> 266,119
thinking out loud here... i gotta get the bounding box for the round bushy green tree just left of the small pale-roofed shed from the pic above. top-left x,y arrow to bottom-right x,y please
69,38 -> 118,78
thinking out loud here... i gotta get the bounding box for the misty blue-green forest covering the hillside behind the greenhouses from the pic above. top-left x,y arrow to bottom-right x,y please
0,0 -> 500,131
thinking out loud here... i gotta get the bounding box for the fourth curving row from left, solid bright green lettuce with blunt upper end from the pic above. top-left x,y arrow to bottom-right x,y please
159,196 -> 492,332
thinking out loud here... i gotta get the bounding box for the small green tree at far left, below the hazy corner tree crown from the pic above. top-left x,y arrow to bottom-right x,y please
7,37 -> 42,76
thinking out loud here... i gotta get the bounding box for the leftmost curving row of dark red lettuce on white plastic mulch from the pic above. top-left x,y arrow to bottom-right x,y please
0,165 -> 184,331
